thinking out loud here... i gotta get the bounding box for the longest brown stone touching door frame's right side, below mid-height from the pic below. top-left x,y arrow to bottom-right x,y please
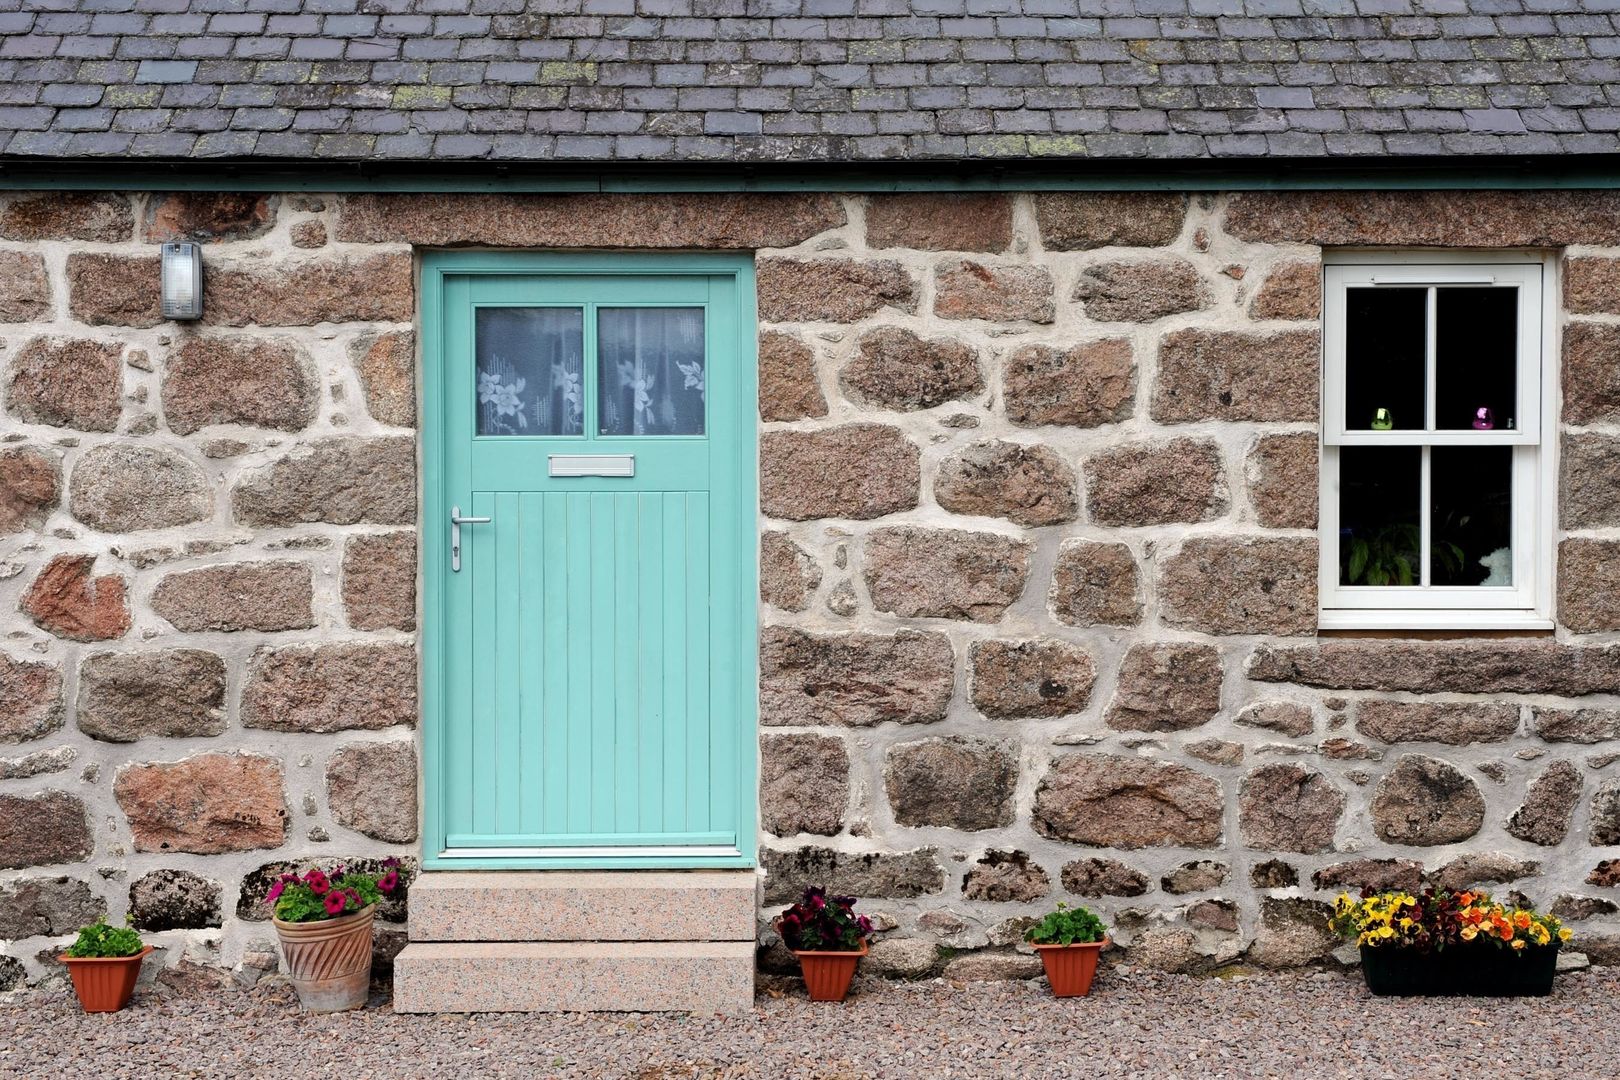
760,627 -> 956,727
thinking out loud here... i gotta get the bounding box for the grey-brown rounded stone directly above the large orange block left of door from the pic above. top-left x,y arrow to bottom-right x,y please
78,649 -> 225,743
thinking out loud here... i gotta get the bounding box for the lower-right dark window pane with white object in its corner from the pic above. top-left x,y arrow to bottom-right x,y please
1429,447 -> 1513,585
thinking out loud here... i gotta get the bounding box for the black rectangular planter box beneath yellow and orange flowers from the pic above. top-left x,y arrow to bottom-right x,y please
1361,944 -> 1558,997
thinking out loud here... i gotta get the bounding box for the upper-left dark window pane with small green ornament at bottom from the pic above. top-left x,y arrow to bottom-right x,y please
1345,288 -> 1429,431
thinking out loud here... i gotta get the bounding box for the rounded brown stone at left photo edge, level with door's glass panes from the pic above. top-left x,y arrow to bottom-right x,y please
6,337 -> 123,431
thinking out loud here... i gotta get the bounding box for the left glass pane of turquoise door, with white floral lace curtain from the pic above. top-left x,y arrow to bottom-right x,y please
473,308 -> 585,436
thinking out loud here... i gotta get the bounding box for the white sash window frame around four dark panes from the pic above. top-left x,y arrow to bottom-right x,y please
1317,251 -> 1558,630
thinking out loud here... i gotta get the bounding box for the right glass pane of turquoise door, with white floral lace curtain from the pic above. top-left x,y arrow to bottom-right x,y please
596,308 -> 708,436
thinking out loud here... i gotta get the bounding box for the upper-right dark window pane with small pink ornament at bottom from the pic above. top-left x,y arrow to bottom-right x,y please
1434,287 -> 1518,431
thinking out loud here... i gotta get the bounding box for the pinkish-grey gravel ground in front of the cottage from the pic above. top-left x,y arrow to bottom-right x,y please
0,968 -> 1620,1080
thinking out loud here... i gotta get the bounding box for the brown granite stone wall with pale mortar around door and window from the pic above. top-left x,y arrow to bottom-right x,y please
0,193 -> 1620,984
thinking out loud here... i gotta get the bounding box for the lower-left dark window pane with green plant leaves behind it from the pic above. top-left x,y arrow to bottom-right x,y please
1338,447 -> 1422,586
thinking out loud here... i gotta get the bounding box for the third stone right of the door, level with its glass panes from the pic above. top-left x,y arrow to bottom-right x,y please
1001,337 -> 1136,427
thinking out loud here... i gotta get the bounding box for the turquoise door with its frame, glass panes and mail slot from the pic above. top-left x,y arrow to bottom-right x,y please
423,253 -> 757,866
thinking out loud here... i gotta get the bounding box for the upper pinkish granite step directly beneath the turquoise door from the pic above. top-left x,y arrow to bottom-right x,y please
410,870 -> 758,942
